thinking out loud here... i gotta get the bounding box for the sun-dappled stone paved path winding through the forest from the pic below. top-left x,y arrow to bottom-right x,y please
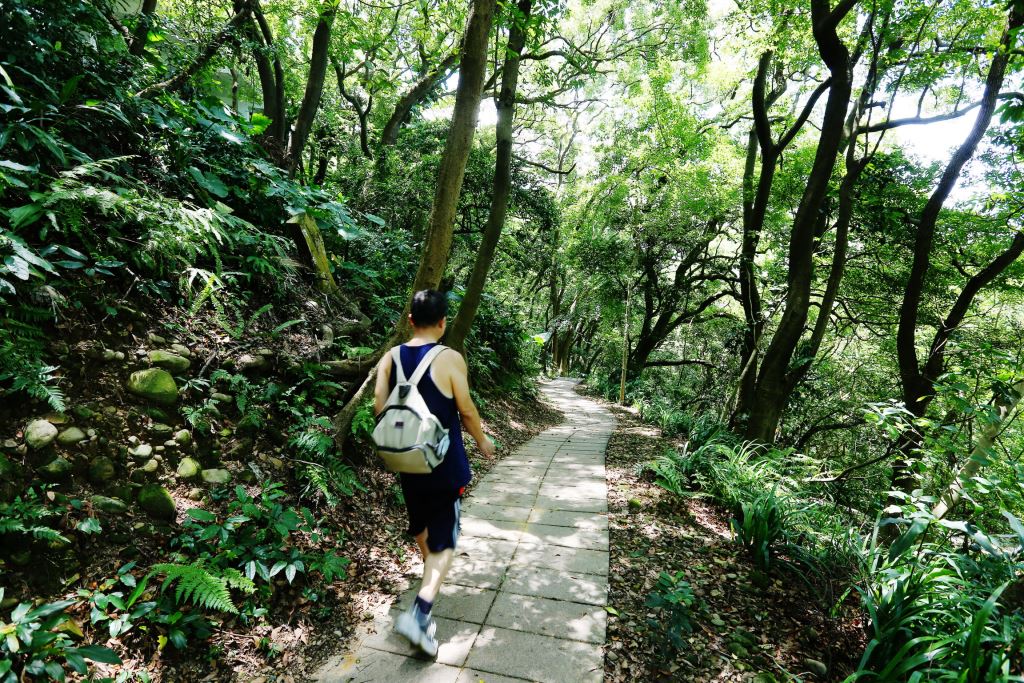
317,380 -> 615,683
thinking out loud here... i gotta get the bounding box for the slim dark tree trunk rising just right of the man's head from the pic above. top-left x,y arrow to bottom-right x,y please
446,0 -> 531,352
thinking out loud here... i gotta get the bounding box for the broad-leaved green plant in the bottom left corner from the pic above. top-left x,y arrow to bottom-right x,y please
0,588 -> 121,683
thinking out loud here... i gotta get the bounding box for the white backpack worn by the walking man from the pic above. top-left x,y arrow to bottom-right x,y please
373,344 -> 449,474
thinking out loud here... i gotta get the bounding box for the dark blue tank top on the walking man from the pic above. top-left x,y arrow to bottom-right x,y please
388,344 -> 473,494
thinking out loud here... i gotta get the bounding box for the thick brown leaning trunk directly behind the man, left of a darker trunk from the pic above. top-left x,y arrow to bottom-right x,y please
334,0 -> 495,446
